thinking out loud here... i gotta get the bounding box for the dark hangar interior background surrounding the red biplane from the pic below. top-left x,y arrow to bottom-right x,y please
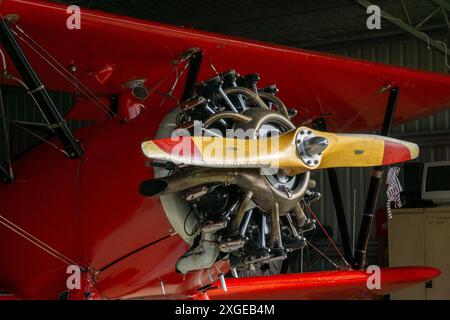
0,0 -> 450,299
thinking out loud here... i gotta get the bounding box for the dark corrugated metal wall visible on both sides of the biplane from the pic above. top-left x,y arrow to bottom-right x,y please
0,32 -> 450,269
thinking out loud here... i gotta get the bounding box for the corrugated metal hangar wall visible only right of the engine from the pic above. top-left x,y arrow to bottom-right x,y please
308,33 -> 450,262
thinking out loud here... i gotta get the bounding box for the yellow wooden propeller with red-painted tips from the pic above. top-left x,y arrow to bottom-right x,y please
142,127 -> 419,175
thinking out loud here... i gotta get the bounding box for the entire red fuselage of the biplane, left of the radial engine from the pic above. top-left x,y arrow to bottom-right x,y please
0,104 -> 230,298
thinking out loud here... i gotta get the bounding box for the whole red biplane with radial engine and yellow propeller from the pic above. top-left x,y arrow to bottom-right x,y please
0,0 -> 444,299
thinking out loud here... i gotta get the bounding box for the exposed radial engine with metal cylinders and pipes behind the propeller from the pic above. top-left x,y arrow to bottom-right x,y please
143,70 -> 318,273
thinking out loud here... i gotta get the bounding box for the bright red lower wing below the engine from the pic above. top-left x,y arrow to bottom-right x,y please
203,267 -> 441,300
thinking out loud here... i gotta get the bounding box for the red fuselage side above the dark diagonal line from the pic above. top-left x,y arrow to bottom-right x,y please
0,107 -> 174,298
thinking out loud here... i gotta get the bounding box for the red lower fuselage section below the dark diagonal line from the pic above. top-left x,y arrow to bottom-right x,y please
96,236 -> 229,299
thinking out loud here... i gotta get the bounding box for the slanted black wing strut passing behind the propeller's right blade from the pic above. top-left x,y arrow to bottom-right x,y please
353,87 -> 400,269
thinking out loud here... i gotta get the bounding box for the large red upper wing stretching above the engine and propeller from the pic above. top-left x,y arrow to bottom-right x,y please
0,0 -> 450,132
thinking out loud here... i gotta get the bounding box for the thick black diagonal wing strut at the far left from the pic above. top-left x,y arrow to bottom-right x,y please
0,18 -> 83,159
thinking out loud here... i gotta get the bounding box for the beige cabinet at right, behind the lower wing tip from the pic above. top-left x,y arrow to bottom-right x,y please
389,207 -> 450,300
